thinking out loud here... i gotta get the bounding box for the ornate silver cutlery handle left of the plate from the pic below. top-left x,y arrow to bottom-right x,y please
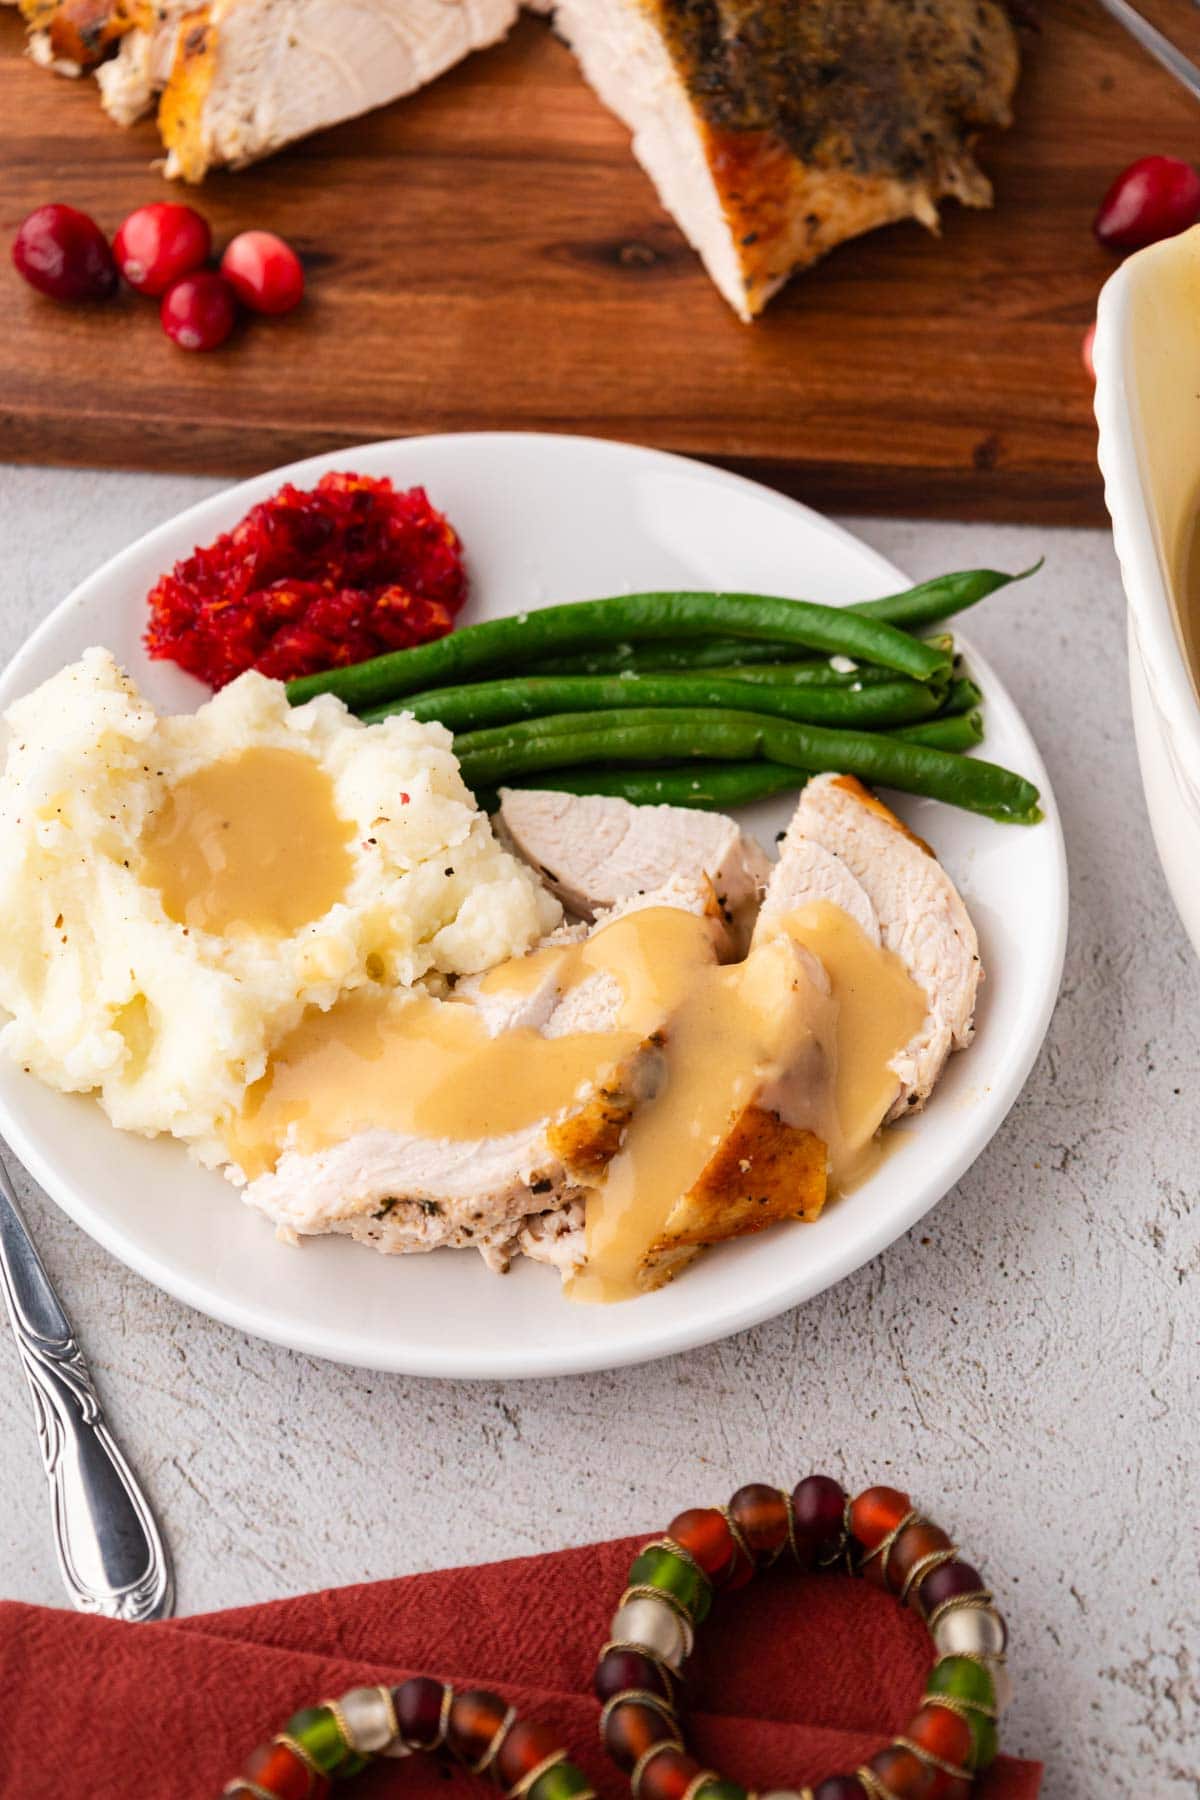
0,1163 -> 175,1620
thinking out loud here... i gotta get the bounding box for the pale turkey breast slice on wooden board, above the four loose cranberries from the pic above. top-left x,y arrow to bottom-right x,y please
158,0 -> 520,182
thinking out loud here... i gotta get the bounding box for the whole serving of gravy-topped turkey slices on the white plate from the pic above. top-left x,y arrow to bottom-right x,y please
230,776 -> 981,1300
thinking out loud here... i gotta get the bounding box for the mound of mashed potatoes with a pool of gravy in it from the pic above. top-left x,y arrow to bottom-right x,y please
0,650 -> 560,1163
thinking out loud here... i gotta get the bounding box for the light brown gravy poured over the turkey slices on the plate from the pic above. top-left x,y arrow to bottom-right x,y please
228,902 -> 925,1300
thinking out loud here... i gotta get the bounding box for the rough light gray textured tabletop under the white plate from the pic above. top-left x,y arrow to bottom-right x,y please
0,470 -> 1200,1800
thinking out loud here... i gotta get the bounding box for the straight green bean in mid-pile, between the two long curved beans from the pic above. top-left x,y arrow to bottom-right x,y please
376,675 -> 943,731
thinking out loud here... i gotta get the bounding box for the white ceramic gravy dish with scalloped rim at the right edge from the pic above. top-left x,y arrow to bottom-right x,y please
1096,225 -> 1200,952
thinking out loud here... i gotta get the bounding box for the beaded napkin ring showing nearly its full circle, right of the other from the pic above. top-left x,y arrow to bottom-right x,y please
596,1474 -> 1011,1800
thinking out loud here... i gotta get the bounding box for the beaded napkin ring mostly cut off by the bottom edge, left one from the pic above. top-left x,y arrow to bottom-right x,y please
223,1676 -> 596,1800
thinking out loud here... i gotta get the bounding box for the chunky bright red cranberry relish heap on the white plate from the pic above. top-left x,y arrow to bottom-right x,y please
146,473 -> 466,688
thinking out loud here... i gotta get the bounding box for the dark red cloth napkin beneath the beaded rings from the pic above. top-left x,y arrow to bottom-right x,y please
0,1533 -> 1042,1800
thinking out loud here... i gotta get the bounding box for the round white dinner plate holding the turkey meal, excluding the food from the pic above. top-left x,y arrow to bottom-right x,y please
0,434 -> 1067,1377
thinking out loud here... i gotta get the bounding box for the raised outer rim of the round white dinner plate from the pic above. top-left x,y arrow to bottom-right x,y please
0,430 -> 1069,1381
